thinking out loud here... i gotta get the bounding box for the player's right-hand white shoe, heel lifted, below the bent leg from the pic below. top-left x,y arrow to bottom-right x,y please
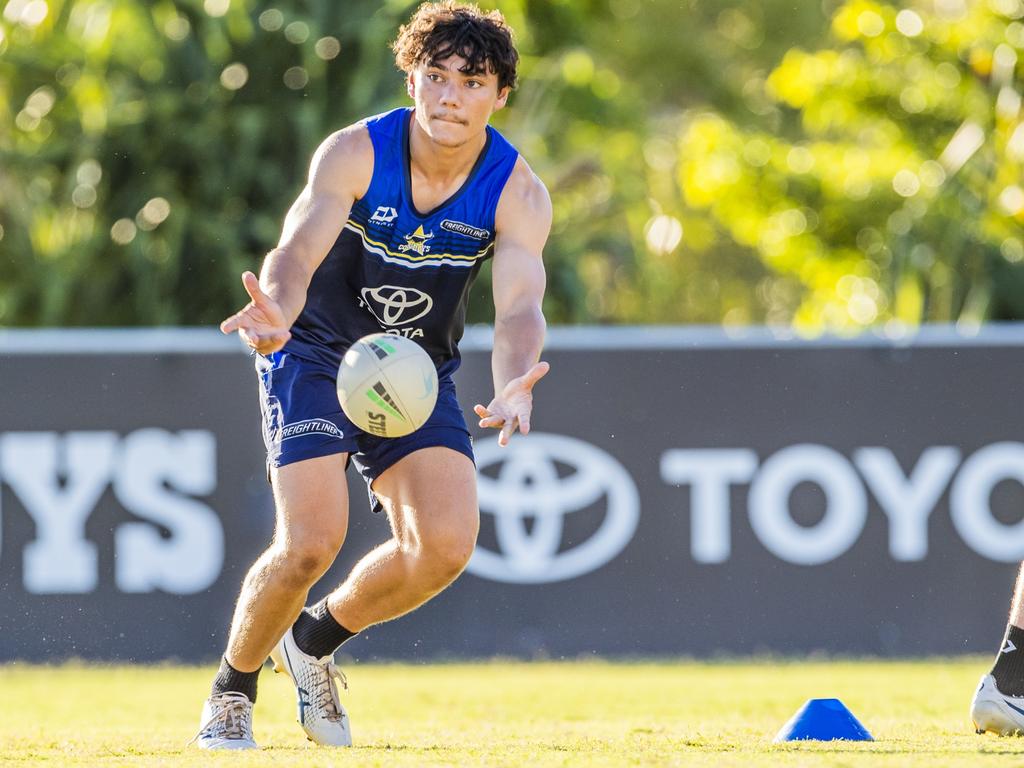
270,628 -> 352,746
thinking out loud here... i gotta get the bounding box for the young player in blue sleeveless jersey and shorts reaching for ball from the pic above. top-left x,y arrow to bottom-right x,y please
196,1 -> 551,750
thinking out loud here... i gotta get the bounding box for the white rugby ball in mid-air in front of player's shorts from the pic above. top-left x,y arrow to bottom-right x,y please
338,334 -> 437,437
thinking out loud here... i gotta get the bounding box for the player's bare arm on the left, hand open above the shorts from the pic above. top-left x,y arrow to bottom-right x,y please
220,125 -> 374,353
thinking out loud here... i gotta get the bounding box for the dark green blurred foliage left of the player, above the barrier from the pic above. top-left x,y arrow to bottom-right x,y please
0,0 -> 415,325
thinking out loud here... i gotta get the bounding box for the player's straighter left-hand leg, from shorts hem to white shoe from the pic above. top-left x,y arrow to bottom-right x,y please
198,454 -> 348,749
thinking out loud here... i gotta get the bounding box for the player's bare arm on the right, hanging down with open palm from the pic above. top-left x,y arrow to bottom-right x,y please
474,159 -> 551,445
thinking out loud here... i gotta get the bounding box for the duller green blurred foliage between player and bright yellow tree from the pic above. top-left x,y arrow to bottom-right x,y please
485,0 -> 824,323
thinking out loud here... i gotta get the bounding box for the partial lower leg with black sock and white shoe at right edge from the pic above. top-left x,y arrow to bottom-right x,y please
971,563 -> 1024,735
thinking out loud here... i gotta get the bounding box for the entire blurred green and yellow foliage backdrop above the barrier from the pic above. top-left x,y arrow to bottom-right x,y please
0,0 -> 1024,333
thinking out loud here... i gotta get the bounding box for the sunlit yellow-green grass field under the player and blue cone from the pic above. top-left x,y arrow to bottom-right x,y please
0,657 -> 1024,768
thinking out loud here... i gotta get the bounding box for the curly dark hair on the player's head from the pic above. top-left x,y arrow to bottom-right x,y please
391,0 -> 519,89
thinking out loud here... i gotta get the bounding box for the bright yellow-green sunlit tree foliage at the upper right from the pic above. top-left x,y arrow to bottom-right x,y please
679,0 -> 1024,335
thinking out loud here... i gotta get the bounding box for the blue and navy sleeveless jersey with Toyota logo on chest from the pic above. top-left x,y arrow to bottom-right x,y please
285,109 -> 518,376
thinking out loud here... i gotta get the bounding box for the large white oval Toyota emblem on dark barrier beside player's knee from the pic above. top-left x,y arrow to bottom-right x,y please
467,432 -> 640,584
